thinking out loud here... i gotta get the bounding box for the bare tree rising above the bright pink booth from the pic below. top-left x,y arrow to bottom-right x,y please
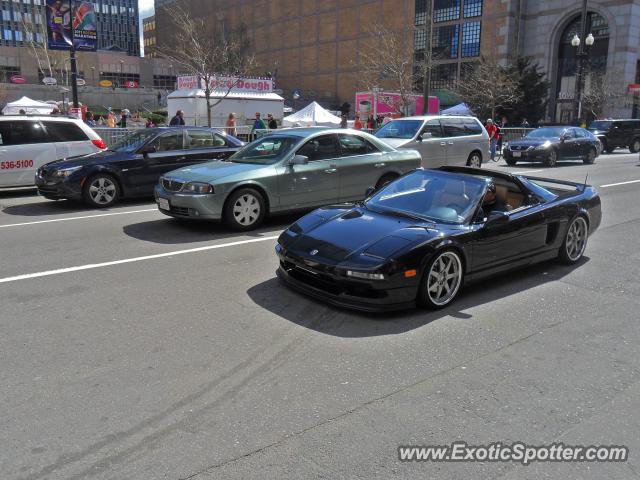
354,24 -> 415,117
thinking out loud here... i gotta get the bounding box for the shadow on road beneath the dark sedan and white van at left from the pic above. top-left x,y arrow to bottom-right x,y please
2,199 -> 155,217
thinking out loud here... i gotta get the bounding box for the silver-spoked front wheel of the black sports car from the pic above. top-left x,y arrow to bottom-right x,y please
417,250 -> 463,308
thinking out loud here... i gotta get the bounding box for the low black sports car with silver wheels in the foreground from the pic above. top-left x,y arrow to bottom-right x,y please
276,167 -> 601,311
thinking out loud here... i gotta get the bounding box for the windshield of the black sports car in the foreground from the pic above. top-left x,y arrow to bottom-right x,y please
365,170 -> 485,224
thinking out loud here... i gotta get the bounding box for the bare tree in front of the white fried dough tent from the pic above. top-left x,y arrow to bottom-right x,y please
157,3 -> 256,126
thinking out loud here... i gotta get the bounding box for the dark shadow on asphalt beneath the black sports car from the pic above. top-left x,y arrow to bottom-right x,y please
247,257 -> 589,338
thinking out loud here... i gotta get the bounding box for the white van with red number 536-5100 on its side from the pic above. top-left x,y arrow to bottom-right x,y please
0,115 -> 107,188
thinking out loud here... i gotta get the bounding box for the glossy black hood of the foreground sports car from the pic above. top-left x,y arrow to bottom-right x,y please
280,206 -> 460,264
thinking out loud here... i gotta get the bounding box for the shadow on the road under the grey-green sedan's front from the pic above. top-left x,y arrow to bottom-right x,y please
122,215 -> 300,245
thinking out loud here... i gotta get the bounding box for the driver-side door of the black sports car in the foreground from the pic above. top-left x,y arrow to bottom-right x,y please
472,204 -> 547,273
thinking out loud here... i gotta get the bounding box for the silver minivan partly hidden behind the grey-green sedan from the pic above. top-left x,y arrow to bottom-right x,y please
375,115 -> 489,168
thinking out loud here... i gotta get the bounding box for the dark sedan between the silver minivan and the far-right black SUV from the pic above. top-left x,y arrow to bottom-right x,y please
502,127 -> 602,167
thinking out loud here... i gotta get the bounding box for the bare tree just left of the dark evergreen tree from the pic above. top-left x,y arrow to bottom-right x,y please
454,57 -> 522,118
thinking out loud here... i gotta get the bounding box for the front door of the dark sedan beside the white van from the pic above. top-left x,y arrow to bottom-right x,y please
129,129 -> 187,194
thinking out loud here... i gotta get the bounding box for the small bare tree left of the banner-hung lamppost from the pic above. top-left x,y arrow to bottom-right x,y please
20,12 -> 69,83
